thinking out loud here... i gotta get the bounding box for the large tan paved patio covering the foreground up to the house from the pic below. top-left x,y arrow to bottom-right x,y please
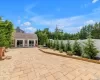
0,48 -> 100,80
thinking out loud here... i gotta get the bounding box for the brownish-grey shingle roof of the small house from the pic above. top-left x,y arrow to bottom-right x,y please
14,33 -> 38,39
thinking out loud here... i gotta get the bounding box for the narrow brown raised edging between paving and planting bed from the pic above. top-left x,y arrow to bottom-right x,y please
39,48 -> 100,64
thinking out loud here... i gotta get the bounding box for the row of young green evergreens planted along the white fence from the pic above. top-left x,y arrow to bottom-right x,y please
46,38 -> 99,59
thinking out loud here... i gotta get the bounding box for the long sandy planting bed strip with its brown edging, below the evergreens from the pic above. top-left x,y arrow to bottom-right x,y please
39,48 -> 100,64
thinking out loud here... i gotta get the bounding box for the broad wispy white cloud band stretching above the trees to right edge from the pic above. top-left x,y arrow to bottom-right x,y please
30,8 -> 100,33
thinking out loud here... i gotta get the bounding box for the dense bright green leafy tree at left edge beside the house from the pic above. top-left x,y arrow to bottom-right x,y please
0,19 -> 14,47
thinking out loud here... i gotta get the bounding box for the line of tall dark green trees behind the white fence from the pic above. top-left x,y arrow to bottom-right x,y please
35,22 -> 100,44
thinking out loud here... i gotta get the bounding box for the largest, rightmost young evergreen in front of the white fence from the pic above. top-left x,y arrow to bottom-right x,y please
82,38 -> 99,59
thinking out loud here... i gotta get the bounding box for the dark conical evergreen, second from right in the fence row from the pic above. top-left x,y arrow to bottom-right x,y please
73,40 -> 82,56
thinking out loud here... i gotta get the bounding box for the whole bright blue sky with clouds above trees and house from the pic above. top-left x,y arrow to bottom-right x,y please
0,0 -> 100,33
